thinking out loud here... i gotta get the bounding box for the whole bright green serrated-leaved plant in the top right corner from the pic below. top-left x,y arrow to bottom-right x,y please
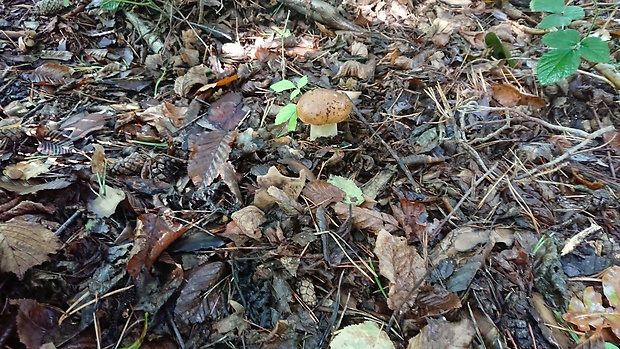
530,0 -> 611,85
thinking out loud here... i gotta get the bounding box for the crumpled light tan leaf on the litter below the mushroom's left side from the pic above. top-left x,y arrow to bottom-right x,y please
254,166 -> 306,209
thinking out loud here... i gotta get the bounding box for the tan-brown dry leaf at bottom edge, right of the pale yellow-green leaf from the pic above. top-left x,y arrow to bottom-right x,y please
407,318 -> 476,349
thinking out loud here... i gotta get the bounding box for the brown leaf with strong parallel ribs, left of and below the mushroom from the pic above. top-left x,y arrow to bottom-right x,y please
187,131 -> 236,186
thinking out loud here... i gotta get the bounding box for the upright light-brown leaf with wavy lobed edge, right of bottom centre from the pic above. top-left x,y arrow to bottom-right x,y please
374,230 -> 426,312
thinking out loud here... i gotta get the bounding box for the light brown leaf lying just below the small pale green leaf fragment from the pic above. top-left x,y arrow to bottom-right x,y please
333,202 -> 398,234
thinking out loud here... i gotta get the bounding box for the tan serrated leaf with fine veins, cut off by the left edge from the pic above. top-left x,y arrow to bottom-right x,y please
0,220 -> 60,279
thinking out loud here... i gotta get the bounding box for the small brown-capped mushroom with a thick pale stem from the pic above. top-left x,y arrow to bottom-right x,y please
297,88 -> 353,140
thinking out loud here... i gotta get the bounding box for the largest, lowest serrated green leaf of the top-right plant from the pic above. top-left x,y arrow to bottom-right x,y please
536,48 -> 580,85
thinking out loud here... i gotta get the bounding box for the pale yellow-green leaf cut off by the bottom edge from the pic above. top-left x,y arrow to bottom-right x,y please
329,321 -> 394,349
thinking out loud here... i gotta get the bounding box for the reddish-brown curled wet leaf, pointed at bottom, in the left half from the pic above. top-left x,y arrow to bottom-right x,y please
127,213 -> 186,279
